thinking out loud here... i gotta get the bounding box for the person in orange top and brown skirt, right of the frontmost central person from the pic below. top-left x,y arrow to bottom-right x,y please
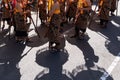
71,0 -> 91,38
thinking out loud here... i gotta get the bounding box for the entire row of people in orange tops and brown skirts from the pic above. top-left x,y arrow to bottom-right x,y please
0,0 -> 116,49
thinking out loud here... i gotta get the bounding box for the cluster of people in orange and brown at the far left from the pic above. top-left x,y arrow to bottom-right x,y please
0,0 -> 32,42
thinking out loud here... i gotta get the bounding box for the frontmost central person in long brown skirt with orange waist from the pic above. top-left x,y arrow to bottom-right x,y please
48,0 -> 61,51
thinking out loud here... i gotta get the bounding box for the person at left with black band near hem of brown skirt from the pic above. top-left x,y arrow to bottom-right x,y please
14,0 -> 29,42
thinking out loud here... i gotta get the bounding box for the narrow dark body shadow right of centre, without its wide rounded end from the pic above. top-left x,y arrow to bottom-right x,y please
67,35 -> 99,67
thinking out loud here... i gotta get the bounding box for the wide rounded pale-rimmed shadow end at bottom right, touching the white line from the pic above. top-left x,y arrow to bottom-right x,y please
72,64 -> 114,80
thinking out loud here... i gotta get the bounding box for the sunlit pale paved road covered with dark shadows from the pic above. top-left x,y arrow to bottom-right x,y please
0,2 -> 120,80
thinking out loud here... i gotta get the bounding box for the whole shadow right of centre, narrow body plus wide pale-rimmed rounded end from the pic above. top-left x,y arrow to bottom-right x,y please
67,35 -> 113,80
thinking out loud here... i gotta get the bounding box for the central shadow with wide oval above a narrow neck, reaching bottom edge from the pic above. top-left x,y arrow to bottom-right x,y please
34,48 -> 71,80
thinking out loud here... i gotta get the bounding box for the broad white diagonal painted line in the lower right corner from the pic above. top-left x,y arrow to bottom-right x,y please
99,53 -> 120,80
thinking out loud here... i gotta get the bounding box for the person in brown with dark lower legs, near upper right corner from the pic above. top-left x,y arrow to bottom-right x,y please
98,0 -> 111,28
